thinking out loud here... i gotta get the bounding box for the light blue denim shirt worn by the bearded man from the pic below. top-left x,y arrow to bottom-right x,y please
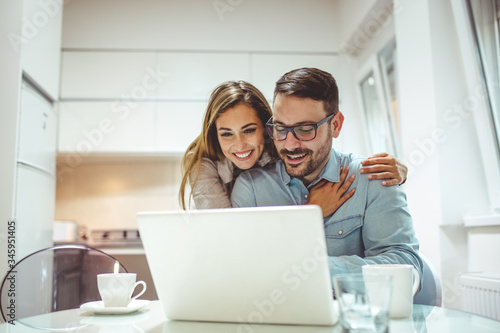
231,149 -> 422,276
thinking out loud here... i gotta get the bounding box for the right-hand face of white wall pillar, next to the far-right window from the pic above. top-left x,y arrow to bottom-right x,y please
429,0 -> 489,220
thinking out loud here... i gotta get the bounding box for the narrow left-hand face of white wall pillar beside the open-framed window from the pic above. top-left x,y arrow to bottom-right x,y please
395,1 -> 442,267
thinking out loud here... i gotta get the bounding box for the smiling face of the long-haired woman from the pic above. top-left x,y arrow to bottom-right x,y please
215,103 -> 264,170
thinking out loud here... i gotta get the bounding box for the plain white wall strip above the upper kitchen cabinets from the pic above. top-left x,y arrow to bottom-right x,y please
62,0 -> 336,52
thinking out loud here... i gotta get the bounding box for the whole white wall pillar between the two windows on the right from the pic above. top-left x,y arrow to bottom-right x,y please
395,1 -> 498,308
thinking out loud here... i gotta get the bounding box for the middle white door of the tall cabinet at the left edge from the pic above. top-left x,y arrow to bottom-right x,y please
18,85 -> 57,174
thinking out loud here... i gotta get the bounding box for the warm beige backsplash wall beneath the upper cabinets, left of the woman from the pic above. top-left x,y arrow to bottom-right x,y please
55,158 -> 181,230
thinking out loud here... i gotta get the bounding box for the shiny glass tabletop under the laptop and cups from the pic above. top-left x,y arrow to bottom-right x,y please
0,301 -> 500,333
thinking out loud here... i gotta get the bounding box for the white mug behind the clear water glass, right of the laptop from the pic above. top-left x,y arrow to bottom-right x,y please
362,264 -> 420,318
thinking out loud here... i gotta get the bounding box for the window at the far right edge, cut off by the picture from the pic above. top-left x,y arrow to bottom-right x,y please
451,0 -> 500,214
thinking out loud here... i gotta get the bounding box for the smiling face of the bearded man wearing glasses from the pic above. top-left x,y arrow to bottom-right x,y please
273,94 -> 343,185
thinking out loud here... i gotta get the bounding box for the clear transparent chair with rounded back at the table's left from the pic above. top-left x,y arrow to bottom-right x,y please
0,245 -> 127,321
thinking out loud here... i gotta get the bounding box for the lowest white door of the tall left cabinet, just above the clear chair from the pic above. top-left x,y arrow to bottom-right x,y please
15,164 -> 55,260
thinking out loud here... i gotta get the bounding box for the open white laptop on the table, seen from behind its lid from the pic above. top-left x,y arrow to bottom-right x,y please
137,205 -> 338,325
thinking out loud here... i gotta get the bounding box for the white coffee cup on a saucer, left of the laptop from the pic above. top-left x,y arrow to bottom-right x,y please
97,273 -> 147,307
